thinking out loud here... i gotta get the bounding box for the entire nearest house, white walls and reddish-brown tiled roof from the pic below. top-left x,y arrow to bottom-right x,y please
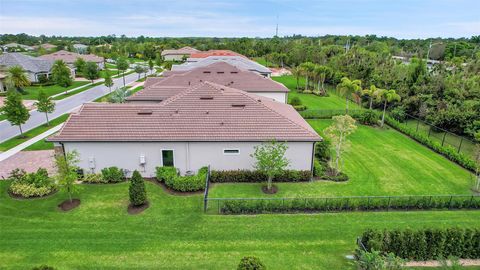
49,82 -> 321,177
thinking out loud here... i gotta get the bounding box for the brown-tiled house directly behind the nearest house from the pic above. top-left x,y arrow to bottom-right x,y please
127,62 -> 289,103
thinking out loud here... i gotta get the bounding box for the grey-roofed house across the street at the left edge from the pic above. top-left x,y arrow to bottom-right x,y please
0,53 -> 53,82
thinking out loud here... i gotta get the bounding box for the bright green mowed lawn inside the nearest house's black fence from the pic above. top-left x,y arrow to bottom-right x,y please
210,120 -> 474,197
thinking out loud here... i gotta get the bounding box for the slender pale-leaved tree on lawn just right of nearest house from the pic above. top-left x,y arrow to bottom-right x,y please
325,115 -> 357,175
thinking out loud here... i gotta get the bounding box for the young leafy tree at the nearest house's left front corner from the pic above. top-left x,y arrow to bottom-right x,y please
55,150 -> 80,202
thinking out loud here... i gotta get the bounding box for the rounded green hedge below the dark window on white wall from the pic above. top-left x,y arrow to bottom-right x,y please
156,167 -> 208,192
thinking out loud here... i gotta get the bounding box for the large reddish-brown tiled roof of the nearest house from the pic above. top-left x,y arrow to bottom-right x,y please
49,82 -> 321,142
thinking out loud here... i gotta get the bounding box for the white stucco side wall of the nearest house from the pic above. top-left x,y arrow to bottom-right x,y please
64,142 -> 313,177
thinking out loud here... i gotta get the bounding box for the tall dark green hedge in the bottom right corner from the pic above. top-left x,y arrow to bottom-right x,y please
359,228 -> 480,261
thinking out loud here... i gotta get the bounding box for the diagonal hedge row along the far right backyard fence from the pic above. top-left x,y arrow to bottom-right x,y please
385,115 -> 476,171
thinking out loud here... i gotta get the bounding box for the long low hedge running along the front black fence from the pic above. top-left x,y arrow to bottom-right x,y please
219,196 -> 480,214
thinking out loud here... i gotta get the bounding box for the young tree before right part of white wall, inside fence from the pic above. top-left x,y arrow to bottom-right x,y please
251,140 -> 290,191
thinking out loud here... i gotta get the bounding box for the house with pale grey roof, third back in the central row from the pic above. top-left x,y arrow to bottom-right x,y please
172,56 -> 272,77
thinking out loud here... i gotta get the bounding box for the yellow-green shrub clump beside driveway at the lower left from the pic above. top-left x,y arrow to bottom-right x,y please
9,168 -> 56,198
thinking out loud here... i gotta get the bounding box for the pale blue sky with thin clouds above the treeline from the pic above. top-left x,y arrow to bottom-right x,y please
0,0 -> 480,38
